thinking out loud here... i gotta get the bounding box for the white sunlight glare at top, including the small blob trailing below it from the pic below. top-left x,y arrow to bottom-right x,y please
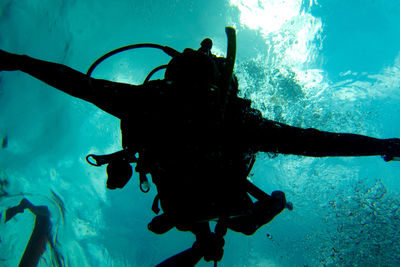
230,0 -> 326,98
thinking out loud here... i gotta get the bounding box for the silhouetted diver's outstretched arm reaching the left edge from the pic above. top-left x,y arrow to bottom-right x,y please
0,50 -> 141,118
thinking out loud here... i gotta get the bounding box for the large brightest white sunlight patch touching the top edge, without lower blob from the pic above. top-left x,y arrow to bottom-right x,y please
231,0 -> 322,68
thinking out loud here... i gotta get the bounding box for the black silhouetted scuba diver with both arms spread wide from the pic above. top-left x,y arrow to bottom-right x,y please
0,27 -> 400,266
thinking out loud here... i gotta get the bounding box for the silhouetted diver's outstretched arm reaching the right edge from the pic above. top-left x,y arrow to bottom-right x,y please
254,119 -> 400,161
